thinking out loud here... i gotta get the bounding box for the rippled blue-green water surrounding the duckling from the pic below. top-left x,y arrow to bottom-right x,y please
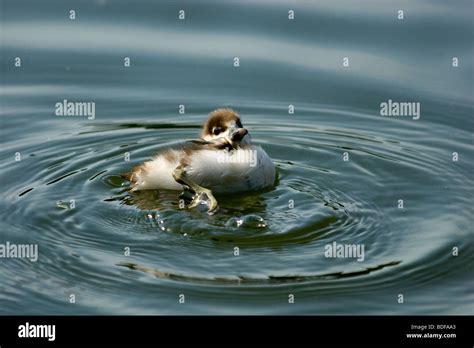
0,1 -> 474,314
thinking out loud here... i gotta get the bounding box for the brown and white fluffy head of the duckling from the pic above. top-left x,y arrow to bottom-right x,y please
201,109 -> 250,147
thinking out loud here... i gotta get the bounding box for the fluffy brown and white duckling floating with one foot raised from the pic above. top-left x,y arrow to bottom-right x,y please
125,108 -> 276,214
